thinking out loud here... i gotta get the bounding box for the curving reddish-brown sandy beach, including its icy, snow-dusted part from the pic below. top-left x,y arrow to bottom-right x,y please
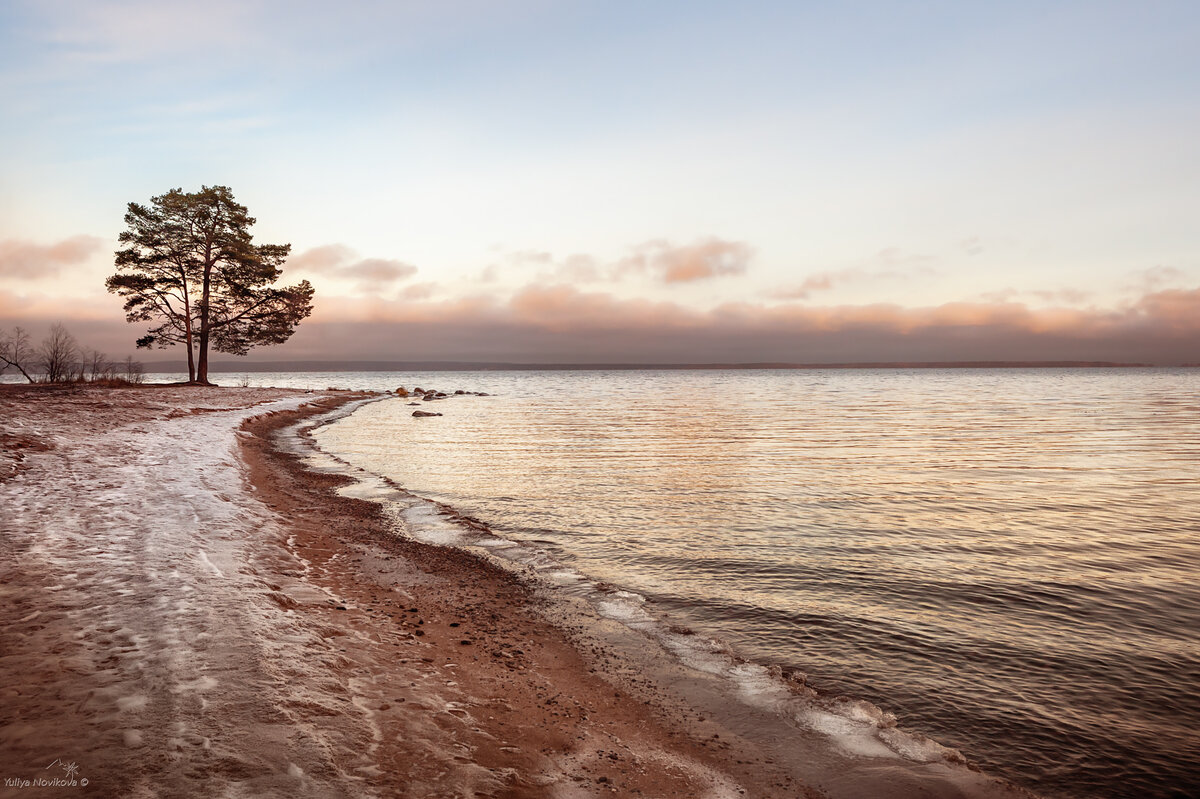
0,386 -> 1025,798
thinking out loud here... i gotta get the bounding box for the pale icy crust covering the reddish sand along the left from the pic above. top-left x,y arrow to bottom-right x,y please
0,390 -> 386,797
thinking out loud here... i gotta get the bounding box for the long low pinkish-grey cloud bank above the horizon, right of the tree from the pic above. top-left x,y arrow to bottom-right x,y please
278,278 -> 1200,364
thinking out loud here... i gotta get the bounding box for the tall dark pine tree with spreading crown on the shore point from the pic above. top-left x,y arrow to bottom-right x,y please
104,186 -> 312,385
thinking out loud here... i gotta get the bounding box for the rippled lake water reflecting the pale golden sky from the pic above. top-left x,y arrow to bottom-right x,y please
307,370 -> 1200,797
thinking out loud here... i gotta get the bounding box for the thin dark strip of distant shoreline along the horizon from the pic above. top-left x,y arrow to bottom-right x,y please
136,361 -> 1166,374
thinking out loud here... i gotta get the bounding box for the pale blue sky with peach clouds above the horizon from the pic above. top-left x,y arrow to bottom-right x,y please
0,0 -> 1200,364
